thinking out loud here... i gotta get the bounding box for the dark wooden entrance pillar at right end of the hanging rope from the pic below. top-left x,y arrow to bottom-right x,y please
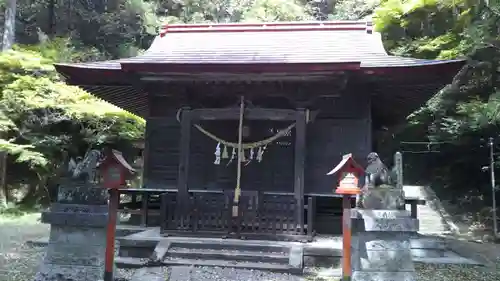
293,108 -> 306,231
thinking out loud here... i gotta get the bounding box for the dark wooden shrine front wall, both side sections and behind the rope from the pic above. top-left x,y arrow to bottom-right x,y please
144,82 -> 372,194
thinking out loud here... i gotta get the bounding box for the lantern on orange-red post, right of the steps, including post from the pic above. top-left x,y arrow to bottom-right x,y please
327,154 -> 364,281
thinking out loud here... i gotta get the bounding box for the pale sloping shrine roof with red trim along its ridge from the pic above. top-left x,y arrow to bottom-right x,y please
121,21 -> 462,72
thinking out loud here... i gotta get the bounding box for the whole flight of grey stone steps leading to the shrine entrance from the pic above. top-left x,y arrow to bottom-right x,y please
117,237 -> 303,272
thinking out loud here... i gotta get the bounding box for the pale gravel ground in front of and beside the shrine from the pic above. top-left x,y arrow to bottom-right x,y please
0,214 -> 500,281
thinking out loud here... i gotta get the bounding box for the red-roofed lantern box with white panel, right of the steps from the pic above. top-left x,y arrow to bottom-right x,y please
327,153 -> 364,195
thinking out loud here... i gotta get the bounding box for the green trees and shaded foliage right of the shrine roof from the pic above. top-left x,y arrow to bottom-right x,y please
375,0 -> 500,224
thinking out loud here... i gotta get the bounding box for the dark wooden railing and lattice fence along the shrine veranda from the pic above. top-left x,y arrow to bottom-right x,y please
115,188 -> 425,239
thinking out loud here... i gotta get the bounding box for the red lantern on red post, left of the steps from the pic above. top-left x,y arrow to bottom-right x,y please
99,150 -> 135,281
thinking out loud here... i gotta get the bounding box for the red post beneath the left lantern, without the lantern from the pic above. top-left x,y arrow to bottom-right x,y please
104,188 -> 119,281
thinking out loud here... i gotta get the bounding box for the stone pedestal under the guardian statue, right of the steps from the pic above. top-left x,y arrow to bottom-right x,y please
352,188 -> 418,281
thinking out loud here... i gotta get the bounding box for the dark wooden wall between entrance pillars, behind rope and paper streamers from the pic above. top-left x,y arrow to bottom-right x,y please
188,121 -> 294,193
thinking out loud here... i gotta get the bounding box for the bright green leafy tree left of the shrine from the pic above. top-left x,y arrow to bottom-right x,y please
0,46 -> 145,203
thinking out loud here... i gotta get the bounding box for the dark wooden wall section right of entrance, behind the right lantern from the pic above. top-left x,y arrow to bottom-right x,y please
305,91 -> 372,194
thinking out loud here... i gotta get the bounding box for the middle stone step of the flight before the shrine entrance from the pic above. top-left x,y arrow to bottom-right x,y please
167,248 -> 289,264
